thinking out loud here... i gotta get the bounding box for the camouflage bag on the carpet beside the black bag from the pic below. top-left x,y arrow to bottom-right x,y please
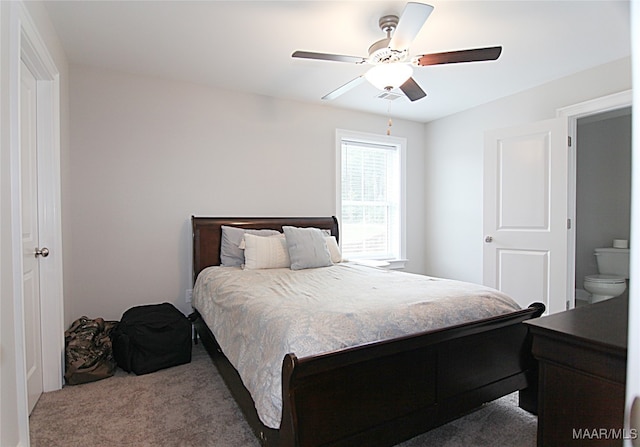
64,317 -> 118,385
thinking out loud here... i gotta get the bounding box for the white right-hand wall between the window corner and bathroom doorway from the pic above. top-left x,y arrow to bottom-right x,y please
425,58 -> 631,283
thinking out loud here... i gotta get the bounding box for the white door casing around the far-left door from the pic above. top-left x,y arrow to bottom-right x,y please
8,2 -> 64,445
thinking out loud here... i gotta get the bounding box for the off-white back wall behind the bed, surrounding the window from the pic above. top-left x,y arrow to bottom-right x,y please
62,66 -> 425,323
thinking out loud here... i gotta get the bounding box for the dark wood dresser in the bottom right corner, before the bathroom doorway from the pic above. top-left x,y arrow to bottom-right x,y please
525,297 -> 628,447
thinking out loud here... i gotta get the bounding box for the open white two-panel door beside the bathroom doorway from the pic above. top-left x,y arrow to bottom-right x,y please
483,118 -> 568,313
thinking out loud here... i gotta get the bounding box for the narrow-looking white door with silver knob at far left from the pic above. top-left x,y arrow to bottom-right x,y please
20,59 -> 46,413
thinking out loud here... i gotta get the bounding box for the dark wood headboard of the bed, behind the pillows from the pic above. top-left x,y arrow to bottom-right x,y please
191,216 -> 338,284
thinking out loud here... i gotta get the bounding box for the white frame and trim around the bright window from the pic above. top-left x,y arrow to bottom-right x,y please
335,129 -> 407,269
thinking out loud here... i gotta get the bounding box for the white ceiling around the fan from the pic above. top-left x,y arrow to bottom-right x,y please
45,0 -> 631,122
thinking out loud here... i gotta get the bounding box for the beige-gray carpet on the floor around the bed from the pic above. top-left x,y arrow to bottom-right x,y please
30,344 -> 536,447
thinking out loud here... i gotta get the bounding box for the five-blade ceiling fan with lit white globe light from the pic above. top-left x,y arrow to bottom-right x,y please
291,2 -> 502,101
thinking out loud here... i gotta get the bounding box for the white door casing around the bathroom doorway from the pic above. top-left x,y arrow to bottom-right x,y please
556,90 -> 633,308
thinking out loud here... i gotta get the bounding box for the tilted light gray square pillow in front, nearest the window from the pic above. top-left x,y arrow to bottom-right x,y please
282,226 -> 333,270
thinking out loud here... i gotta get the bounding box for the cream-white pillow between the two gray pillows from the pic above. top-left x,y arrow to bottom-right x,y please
244,234 -> 291,270
